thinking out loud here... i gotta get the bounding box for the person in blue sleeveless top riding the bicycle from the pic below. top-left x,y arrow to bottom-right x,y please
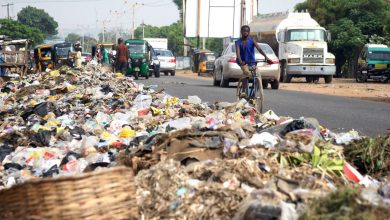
235,25 -> 272,95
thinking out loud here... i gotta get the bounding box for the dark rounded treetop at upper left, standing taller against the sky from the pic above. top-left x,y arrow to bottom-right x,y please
18,6 -> 58,36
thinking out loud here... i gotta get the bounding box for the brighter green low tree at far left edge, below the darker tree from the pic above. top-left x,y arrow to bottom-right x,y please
0,19 -> 44,44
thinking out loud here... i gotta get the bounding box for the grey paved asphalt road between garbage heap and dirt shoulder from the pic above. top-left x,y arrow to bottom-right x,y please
141,76 -> 390,136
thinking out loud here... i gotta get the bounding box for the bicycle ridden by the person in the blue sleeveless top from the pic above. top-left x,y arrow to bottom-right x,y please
236,63 -> 264,113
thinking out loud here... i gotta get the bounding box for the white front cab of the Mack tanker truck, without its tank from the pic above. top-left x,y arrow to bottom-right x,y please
276,13 -> 336,83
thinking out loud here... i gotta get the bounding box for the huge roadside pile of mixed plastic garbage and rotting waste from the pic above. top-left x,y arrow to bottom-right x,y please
0,65 -> 390,219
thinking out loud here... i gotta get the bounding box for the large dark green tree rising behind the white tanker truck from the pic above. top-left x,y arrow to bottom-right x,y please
295,0 -> 390,76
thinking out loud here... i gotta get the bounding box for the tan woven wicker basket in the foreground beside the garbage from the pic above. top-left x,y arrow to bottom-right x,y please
0,167 -> 138,220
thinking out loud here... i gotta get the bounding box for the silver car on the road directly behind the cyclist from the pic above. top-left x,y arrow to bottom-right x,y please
213,43 -> 280,89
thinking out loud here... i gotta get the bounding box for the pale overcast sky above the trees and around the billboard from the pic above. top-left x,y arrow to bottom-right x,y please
0,0 -> 302,35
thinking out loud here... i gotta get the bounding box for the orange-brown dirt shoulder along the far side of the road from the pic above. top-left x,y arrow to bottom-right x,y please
176,70 -> 390,103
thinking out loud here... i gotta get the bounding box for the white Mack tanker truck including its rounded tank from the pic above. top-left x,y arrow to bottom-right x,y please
250,12 -> 336,83
